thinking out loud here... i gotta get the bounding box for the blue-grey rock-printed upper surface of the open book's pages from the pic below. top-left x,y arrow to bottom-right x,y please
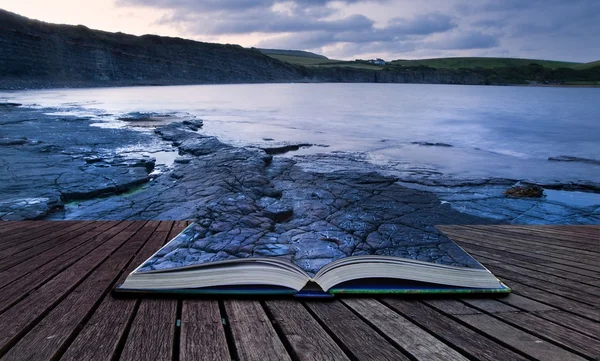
137,219 -> 482,276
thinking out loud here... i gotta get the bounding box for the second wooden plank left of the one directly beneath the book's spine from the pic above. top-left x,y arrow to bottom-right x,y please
224,300 -> 291,361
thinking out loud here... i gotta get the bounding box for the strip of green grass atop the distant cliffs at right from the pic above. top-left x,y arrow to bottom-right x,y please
392,58 -> 584,69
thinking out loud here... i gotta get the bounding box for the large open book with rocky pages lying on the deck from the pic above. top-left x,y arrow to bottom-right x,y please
115,223 -> 510,297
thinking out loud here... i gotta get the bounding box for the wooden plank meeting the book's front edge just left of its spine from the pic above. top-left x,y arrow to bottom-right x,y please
265,300 -> 350,361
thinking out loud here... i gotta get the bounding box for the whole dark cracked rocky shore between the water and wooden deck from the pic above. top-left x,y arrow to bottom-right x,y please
0,106 -> 600,249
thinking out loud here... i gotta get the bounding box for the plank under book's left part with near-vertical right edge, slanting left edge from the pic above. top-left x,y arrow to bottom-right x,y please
120,299 -> 177,361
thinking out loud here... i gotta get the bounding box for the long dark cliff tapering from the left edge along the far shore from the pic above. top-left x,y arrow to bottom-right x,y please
0,9 -> 484,89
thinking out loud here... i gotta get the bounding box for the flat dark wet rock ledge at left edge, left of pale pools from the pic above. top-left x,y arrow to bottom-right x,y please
0,108 -> 164,219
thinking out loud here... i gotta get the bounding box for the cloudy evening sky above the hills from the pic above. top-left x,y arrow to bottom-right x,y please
0,0 -> 600,62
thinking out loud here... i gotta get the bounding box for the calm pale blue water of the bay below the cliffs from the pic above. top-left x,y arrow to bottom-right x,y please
0,84 -> 600,187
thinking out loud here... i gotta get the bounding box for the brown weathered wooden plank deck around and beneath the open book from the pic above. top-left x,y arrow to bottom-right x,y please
0,221 -> 600,361
